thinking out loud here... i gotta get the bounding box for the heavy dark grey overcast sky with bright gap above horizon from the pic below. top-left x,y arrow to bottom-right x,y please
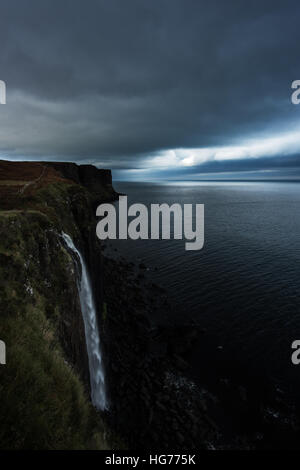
0,0 -> 300,179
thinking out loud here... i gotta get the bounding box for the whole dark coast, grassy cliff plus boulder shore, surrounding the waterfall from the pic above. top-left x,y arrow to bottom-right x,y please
0,161 -> 220,449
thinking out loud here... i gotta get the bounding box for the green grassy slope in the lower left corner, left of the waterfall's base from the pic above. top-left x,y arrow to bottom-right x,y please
0,304 -> 107,449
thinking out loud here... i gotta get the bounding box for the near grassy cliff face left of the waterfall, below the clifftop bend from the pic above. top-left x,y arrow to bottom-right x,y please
0,209 -> 107,449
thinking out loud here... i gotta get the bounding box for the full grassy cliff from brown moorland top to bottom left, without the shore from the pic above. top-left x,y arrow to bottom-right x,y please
0,162 -> 115,448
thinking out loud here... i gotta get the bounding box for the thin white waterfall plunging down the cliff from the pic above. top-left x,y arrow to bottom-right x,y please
62,233 -> 108,410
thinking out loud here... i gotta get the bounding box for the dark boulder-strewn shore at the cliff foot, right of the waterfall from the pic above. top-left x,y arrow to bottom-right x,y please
102,252 -> 217,449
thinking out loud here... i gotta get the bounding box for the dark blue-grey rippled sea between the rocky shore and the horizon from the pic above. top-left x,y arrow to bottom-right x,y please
113,182 -> 300,395
